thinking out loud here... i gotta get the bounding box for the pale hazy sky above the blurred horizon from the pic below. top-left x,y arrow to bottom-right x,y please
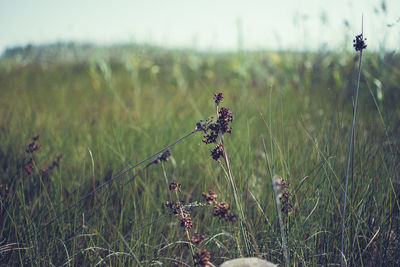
0,0 -> 400,54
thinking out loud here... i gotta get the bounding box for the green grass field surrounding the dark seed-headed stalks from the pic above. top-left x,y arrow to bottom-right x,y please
0,47 -> 400,266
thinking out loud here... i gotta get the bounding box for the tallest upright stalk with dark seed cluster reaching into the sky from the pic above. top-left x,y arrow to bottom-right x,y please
340,18 -> 367,266
